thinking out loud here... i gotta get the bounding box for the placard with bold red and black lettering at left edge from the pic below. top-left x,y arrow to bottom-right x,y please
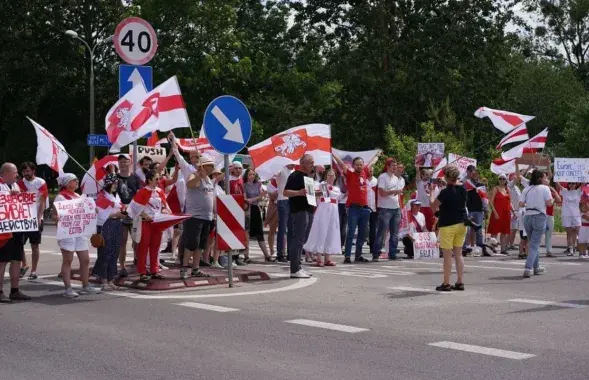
0,192 -> 39,233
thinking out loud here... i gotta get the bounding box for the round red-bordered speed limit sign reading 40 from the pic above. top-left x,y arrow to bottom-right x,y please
114,17 -> 157,65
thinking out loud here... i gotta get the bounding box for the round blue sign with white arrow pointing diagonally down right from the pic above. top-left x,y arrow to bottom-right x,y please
203,95 -> 252,154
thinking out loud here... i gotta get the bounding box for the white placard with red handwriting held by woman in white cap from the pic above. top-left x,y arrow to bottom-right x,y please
54,196 -> 97,240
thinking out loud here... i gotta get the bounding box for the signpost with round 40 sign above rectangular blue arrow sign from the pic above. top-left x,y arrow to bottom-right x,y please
113,17 -> 157,177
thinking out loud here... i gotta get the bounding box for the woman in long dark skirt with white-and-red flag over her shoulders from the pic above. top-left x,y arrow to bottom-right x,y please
92,173 -> 127,291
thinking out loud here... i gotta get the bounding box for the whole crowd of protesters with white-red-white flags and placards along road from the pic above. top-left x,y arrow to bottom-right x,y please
0,78 -> 589,303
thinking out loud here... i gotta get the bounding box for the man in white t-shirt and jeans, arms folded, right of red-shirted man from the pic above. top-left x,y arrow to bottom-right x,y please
372,158 -> 405,262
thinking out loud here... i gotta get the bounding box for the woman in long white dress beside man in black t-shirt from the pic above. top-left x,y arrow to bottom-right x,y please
303,169 -> 342,267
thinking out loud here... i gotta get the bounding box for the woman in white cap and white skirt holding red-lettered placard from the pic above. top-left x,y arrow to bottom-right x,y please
53,173 -> 100,298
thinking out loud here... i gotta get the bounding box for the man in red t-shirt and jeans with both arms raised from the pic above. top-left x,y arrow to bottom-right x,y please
332,154 -> 379,264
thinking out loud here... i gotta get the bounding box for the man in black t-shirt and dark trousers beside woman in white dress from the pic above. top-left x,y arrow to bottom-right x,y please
282,154 -> 315,278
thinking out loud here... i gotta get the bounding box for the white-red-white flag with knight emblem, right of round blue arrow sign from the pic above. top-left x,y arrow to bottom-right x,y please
248,124 -> 331,180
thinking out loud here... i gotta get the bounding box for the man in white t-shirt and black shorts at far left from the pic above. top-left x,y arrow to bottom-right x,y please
17,161 -> 49,280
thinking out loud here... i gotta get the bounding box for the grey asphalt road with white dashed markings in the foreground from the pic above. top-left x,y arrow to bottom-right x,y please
0,227 -> 589,380
